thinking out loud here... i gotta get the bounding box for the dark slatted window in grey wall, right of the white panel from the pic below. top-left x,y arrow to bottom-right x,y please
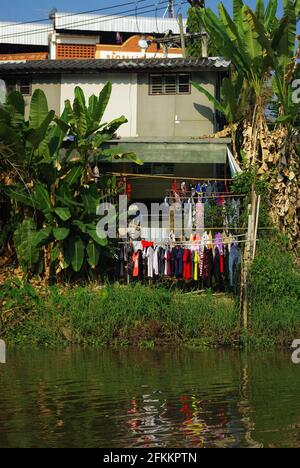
150,73 -> 191,95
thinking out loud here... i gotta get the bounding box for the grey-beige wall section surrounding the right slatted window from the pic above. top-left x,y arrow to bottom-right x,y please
137,72 -> 217,137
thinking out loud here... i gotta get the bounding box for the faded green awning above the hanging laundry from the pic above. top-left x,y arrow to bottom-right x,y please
105,138 -> 230,164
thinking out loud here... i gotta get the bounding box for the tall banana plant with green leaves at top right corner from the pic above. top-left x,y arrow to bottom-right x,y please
190,0 -> 299,130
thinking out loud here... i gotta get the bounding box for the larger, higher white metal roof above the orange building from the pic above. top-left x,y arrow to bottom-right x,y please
55,12 -> 186,34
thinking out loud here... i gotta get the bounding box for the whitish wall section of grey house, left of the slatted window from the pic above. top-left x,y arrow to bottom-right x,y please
60,73 -> 137,137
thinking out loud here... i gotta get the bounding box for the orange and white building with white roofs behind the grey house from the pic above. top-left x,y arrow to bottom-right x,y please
0,12 -> 186,61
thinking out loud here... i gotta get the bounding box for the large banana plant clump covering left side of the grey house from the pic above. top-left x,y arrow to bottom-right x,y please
0,83 -> 141,277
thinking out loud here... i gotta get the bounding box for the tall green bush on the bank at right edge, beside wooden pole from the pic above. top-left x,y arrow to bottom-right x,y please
245,234 -> 300,345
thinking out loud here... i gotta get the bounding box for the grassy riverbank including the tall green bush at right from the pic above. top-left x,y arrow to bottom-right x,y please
0,235 -> 300,349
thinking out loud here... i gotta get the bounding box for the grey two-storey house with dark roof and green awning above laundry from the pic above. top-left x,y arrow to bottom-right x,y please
0,58 -> 230,212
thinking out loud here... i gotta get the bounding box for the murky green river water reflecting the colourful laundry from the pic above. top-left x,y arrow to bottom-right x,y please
0,349 -> 300,448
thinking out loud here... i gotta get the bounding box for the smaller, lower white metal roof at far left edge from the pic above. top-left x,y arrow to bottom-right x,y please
0,23 -> 52,46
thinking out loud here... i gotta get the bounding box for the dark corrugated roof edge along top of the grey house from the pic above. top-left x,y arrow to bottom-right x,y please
0,57 -> 230,74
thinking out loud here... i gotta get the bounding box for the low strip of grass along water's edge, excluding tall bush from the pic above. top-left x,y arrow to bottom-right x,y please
0,280 -> 300,348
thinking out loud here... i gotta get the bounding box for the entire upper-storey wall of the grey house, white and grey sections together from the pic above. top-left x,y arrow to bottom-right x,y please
18,72 -> 217,137
